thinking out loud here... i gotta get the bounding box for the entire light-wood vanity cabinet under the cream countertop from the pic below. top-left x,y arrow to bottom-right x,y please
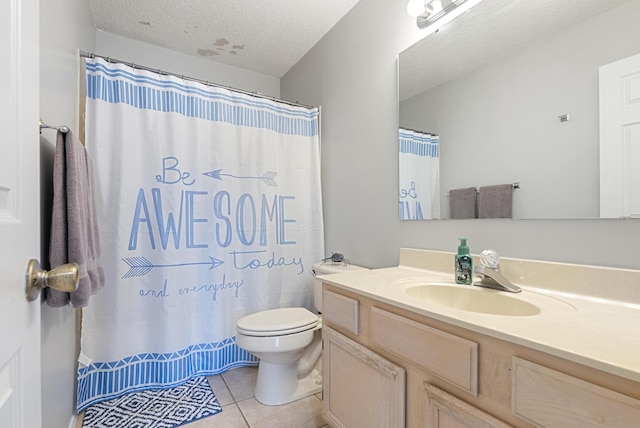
323,284 -> 640,428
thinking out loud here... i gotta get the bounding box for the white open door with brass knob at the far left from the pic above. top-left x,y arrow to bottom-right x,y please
0,0 -> 41,428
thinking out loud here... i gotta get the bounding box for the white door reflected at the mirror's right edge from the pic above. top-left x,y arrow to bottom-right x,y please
600,54 -> 640,218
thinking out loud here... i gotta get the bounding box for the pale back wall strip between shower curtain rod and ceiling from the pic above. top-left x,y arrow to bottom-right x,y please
94,31 -> 280,98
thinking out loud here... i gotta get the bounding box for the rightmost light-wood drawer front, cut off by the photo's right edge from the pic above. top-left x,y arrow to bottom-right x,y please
511,357 -> 640,428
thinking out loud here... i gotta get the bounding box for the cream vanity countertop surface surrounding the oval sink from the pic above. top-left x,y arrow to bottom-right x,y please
318,266 -> 640,382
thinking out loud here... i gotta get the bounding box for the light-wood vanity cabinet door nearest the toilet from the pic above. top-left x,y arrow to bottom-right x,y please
322,325 -> 406,428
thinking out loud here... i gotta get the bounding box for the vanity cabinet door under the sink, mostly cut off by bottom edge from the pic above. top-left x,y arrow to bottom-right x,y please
424,382 -> 511,428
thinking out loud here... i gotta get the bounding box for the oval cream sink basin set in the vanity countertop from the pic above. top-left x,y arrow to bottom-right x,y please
396,281 -> 575,317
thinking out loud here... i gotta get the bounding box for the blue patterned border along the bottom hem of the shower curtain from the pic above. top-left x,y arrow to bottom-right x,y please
77,337 -> 258,412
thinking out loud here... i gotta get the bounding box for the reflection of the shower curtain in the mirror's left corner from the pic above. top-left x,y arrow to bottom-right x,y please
398,128 -> 440,220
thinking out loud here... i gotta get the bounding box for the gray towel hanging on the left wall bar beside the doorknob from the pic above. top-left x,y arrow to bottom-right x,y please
45,131 -> 104,308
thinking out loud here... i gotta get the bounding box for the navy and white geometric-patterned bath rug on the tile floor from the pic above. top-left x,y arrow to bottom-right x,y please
82,376 -> 222,428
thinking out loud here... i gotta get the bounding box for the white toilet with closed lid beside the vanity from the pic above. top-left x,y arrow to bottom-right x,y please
236,263 -> 366,406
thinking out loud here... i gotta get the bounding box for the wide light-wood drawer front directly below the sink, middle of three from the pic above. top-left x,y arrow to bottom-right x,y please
370,308 -> 478,395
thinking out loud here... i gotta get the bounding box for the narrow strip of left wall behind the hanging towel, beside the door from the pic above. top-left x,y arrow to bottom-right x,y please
39,0 -> 95,428
